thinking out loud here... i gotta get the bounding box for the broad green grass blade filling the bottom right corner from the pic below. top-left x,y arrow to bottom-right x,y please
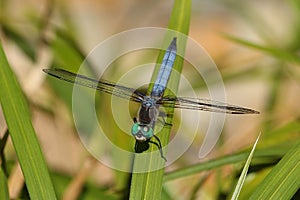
250,138 -> 300,199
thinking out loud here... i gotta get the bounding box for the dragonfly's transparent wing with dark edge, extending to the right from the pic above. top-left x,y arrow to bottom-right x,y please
157,96 -> 259,114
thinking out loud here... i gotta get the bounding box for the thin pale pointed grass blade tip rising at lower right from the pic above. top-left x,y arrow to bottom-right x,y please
231,134 -> 260,199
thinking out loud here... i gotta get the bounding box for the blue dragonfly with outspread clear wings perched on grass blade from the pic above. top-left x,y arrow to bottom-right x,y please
43,37 -> 259,161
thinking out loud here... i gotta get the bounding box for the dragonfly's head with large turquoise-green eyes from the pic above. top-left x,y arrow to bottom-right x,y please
131,122 -> 154,141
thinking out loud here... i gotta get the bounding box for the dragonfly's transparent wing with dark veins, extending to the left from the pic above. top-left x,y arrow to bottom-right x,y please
43,68 -> 144,102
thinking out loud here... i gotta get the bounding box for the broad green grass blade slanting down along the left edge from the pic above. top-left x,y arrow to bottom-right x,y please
0,43 -> 56,199
